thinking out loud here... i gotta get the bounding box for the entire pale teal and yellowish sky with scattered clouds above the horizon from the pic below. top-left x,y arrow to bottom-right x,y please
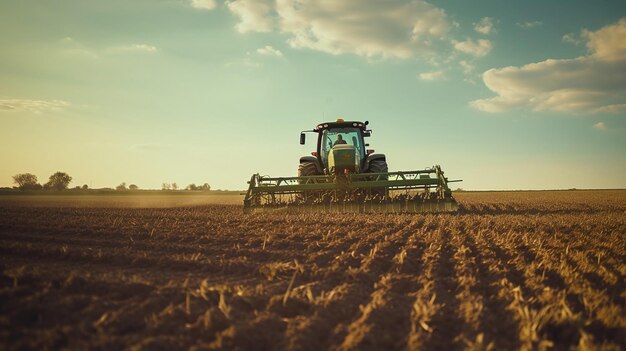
0,0 -> 626,190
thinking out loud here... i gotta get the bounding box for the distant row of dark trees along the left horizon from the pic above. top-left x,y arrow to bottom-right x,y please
13,171 -> 211,191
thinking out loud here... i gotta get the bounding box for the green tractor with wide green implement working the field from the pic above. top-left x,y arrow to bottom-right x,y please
244,119 -> 458,213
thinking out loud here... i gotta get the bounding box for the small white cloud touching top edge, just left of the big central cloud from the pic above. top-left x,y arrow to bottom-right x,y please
226,0 -> 274,33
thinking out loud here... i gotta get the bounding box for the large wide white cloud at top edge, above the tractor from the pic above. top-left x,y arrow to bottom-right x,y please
276,0 -> 450,58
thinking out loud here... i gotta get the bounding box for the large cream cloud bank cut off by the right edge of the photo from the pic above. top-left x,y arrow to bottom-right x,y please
471,19 -> 626,113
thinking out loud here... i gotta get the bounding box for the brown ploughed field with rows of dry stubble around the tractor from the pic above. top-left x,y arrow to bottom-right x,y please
0,191 -> 626,350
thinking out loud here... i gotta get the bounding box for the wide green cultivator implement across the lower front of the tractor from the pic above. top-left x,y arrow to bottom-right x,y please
244,166 -> 458,213
